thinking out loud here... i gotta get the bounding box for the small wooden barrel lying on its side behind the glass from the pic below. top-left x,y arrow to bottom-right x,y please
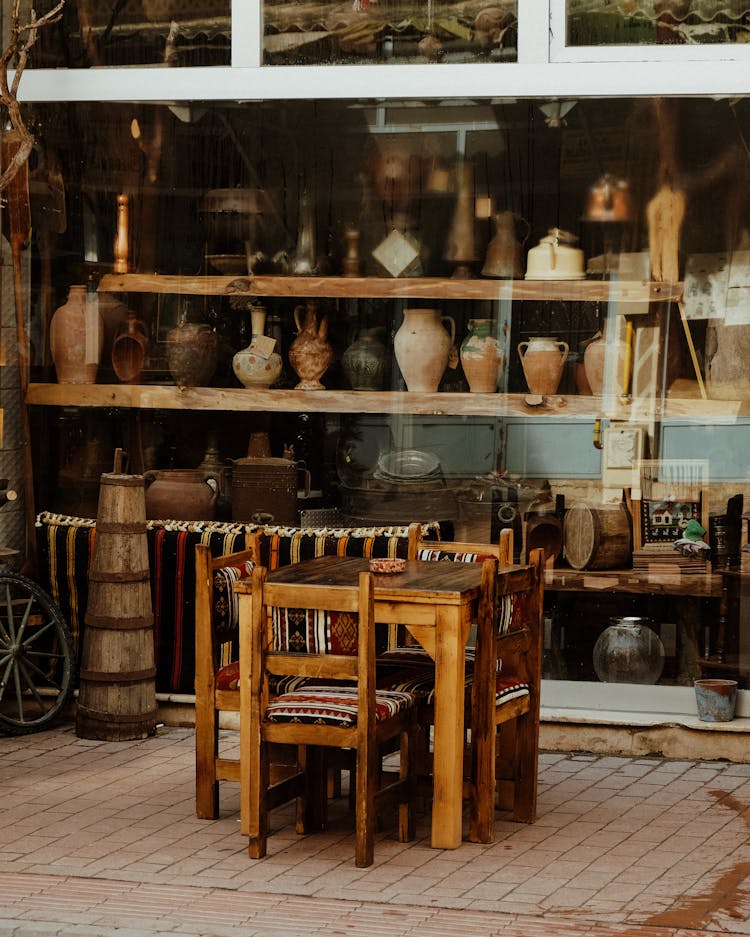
563,503 -> 632,569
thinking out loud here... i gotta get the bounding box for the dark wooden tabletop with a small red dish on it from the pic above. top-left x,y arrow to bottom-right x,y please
234,556 -> 482,605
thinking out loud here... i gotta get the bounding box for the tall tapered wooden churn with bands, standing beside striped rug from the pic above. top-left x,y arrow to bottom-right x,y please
76,474 -> 156,741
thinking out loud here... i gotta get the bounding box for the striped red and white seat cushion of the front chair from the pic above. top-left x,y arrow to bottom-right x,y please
265,685 -> 415,728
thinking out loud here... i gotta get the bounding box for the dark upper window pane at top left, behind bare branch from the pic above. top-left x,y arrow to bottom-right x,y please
22,0 -> 231,68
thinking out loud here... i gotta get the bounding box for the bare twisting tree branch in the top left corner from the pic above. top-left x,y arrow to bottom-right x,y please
0,0 -> 65,192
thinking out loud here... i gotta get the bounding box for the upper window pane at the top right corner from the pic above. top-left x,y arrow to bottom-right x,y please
566,0 -> 750,46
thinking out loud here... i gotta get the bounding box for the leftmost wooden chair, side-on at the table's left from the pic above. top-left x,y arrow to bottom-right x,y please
195,534 -> 260,820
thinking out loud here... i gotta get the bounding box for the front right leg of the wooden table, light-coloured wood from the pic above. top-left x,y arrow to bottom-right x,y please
432,608 -> 468,849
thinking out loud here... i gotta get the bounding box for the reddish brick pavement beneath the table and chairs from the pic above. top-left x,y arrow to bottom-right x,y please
0,725 -> 750,937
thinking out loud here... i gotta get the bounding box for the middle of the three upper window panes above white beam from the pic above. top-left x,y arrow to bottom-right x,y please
263,0 -> 517,65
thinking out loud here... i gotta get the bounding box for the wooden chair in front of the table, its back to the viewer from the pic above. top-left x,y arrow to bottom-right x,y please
240,567 -> 416,867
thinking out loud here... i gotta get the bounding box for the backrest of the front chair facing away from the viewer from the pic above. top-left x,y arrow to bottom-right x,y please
250,566 -> 376,733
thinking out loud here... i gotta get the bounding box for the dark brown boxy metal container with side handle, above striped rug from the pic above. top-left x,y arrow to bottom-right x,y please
232,458 -> 310,527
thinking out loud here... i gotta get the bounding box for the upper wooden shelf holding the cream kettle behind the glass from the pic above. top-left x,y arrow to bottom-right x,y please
99,273 -> 682,303
